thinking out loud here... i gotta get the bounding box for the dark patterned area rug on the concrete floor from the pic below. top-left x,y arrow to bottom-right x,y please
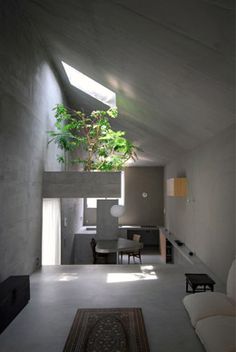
63,308 -> 150,352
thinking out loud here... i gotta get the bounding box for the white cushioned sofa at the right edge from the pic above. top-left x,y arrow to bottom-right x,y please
183,259 -> 236,352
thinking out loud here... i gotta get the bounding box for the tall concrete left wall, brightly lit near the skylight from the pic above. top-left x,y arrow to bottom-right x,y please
0,0 -> 62,280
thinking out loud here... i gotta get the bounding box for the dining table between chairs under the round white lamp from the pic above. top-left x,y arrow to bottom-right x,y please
95,237 -> 143,264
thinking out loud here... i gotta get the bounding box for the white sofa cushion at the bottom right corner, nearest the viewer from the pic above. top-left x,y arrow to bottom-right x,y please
196,316 -> 236,352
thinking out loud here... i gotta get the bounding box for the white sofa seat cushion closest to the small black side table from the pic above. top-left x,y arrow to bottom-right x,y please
183,292 -> 235,327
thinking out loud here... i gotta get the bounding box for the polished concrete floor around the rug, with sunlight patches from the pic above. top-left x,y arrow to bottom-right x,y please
0,264 -> 222,352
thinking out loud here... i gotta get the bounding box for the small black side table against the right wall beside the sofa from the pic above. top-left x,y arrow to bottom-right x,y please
185,273 -> 215,293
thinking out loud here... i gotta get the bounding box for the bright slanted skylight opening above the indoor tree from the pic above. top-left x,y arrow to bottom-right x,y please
61,61 -> 116,107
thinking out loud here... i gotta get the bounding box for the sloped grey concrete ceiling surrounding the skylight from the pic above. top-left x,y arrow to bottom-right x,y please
20,0 -> 235,165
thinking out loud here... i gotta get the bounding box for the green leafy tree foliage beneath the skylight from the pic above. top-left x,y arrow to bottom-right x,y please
48,104 -> 138,171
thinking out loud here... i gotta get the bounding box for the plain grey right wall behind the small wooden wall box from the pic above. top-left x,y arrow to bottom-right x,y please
165,126 -> 235,282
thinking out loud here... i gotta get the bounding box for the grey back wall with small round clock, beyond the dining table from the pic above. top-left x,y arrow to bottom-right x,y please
120,167 -> 163,225
